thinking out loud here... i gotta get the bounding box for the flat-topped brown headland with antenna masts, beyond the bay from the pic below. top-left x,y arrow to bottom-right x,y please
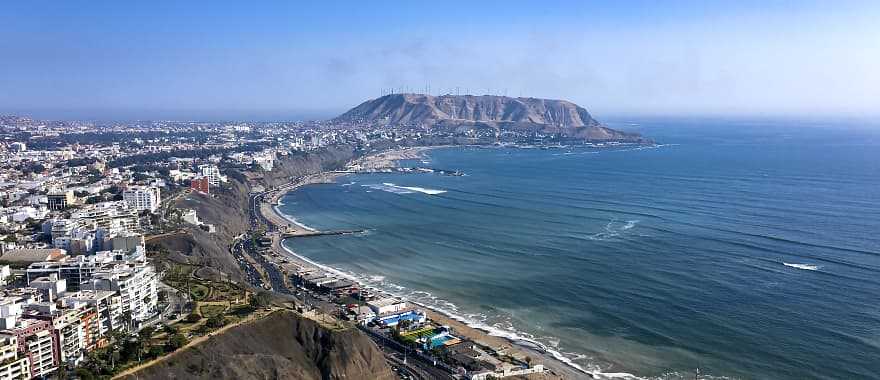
334,94 -> 648,142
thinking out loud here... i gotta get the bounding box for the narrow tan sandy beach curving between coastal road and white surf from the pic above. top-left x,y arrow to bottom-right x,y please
260,147 -> 594,379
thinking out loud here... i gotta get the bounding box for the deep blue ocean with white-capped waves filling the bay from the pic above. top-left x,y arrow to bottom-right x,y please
280,118 -> 880,379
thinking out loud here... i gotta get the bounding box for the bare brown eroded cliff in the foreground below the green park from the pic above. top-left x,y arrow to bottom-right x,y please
120,311 -> 395,380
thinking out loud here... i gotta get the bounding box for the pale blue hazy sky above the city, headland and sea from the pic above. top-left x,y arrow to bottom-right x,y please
0,0 -> 880,120
